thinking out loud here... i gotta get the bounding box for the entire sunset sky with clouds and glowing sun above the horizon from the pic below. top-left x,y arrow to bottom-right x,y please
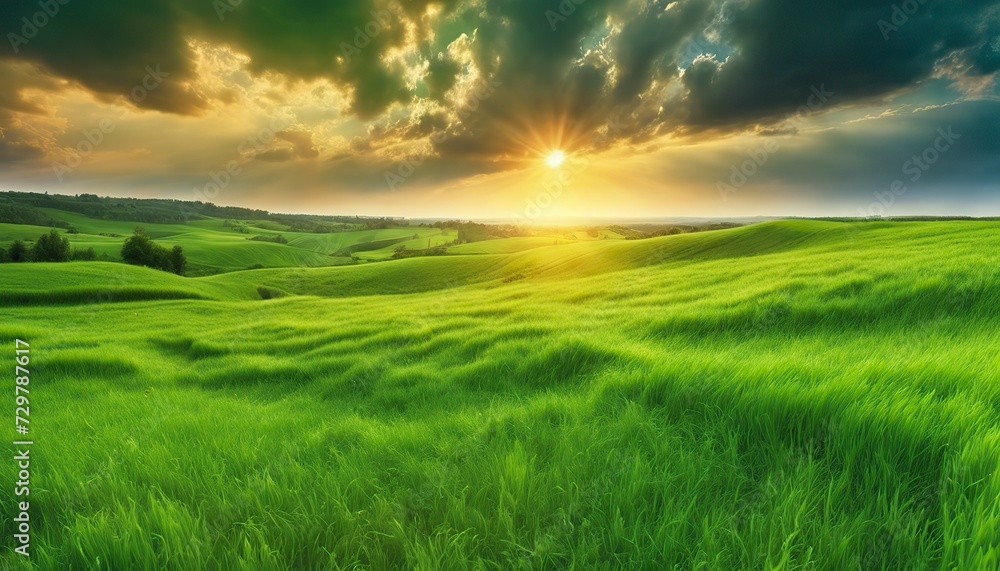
0,0 -> 1000,219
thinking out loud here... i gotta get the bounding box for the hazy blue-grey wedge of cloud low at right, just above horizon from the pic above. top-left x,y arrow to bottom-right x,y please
684,101 -> 1000,203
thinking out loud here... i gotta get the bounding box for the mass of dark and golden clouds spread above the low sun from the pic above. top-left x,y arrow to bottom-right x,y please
0,0 -> 1000,217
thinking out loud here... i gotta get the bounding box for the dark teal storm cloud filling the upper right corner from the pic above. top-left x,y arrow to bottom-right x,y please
671,0 -> 1000,133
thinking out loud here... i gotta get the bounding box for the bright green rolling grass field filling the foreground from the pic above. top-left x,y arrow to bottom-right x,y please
0,221 -> 1000,571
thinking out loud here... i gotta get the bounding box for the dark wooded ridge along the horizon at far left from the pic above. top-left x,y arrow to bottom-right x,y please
0,191 -> 399,233
